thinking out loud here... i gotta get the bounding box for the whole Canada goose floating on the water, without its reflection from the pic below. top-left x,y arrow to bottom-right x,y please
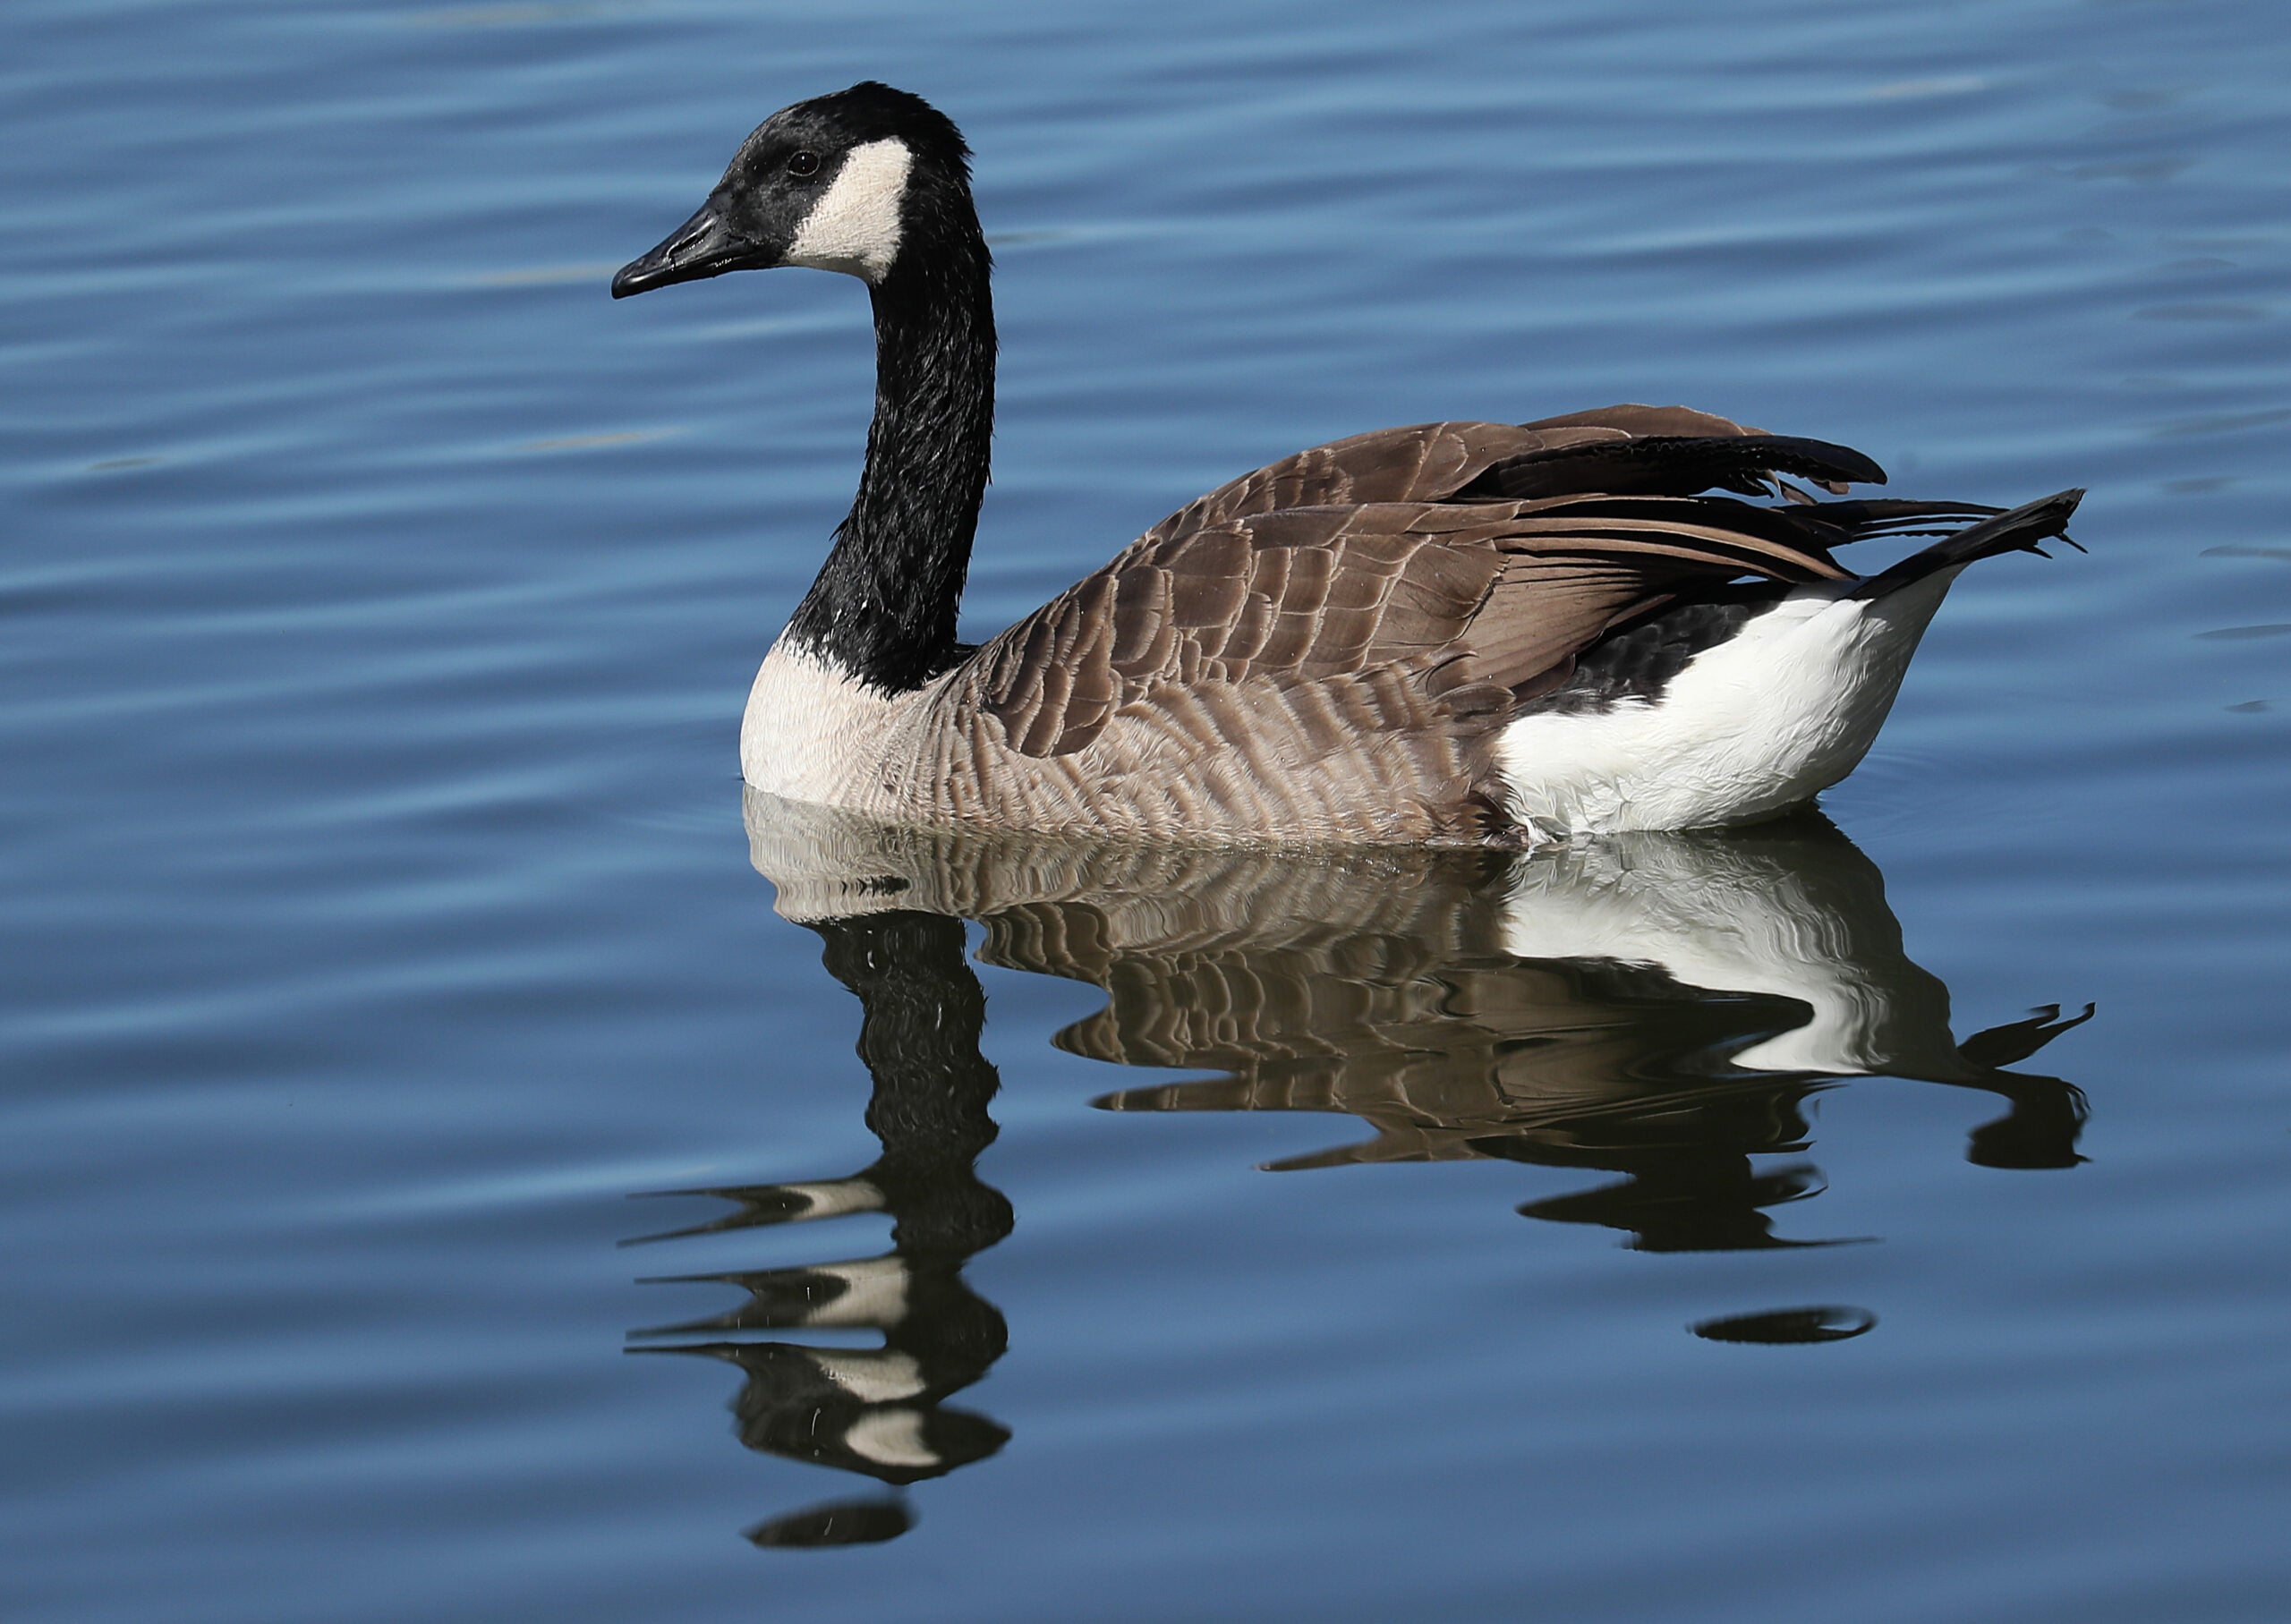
612,82 -> 2082,846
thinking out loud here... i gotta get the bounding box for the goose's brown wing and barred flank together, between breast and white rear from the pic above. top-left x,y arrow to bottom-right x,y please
903,405 -> 1922,838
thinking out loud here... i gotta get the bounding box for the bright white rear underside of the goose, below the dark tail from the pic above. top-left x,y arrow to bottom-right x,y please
1496,565 -> 1963,836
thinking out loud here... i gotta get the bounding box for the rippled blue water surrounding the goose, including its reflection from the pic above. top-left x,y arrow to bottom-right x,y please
0,0 -> 2291,1624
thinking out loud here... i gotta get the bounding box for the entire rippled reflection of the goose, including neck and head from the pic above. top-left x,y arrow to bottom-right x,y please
642,790 -> 2091,1543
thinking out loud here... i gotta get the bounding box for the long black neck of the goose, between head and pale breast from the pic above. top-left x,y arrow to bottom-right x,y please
788,235 -> 994,694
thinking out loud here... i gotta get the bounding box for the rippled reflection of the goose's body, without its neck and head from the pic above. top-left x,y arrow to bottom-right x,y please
749,795 -> 2090,1251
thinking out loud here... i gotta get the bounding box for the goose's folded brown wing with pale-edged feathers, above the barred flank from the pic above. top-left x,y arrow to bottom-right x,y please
967,485 -> 1844,756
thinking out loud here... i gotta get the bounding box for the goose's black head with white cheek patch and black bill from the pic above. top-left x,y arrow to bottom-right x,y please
612,81 -> 978,298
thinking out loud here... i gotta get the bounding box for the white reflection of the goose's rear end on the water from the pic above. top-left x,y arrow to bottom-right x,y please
1503,834 -> 1915,1076
